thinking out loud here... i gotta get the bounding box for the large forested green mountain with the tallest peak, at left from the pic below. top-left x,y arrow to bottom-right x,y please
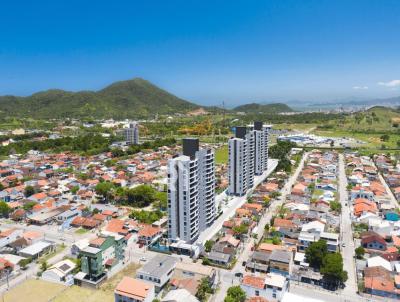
0,78 -> 200,119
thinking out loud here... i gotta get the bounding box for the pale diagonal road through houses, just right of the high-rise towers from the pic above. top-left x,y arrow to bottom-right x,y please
212,153 -> 308,302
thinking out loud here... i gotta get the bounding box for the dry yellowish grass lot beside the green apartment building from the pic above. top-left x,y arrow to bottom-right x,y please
2,264 -> 139,302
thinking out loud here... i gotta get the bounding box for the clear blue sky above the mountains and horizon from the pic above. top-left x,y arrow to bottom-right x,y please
0,0 -> 400,106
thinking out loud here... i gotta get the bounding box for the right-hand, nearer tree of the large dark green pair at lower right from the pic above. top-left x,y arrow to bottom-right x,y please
320,253 -> 347,284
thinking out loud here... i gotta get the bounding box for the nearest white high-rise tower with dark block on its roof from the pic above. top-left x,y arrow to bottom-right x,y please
168,139 -> 216,243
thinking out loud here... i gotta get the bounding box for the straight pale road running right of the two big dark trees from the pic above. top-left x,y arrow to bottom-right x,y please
339,154 -> 358,297
